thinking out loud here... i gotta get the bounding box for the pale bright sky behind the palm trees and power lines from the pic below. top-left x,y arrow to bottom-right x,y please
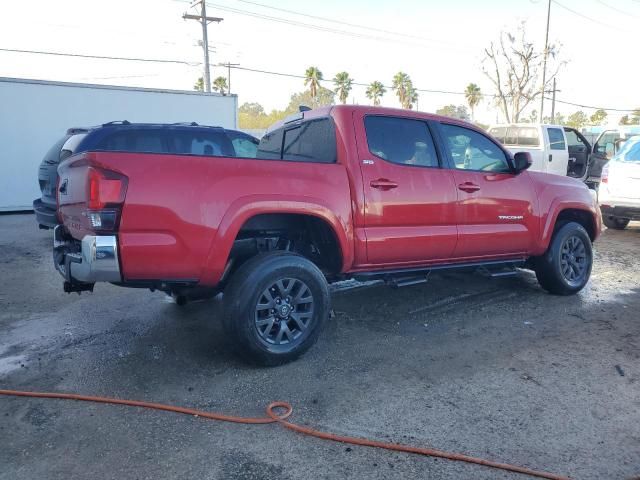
0,0 -> 640,123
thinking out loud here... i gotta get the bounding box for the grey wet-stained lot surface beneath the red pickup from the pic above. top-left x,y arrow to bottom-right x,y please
0,215 -> 640,480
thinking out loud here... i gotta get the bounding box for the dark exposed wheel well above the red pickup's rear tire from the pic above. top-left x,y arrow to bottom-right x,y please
228,213 -> 342,277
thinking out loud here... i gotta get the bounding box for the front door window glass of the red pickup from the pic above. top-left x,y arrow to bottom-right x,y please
441,123 -> 511,172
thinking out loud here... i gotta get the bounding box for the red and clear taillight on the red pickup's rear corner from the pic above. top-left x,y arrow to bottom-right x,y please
86,167 -> 127,232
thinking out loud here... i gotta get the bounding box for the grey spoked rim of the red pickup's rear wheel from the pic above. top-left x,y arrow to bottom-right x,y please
255,278 -> 313,348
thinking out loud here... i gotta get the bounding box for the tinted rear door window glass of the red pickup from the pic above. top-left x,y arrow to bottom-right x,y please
364,116 -> 438,167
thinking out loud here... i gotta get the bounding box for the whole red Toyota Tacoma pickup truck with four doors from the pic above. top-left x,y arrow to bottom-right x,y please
54,105 -> 601,364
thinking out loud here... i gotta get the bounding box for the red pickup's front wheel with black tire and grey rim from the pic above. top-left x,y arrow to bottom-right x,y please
535,222 -> 593,295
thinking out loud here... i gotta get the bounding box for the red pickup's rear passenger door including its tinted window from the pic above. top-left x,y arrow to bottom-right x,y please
354,112 -> 457,266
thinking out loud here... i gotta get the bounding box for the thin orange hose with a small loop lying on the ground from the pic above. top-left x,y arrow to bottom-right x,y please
0,390 -> 570,480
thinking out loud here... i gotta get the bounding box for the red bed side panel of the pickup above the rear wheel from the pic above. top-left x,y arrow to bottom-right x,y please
95,153 -> 353,285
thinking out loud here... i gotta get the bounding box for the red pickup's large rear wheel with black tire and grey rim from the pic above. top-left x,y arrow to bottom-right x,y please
223,252 -> 330,366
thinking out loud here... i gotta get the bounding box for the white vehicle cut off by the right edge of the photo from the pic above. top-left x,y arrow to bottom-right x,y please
598,135 -> 640,230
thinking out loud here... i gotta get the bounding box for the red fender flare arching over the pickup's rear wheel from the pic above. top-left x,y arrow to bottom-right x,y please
200,195 -> 354,285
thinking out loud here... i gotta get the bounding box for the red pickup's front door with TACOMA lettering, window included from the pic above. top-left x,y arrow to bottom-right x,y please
439,123 -> 539,260
